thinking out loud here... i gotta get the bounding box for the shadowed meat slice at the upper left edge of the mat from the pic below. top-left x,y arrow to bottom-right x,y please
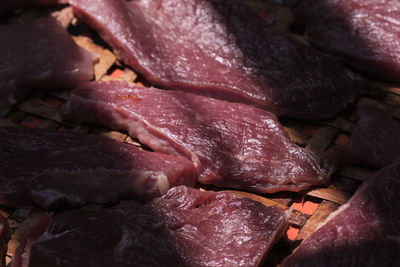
0,18 -> 93,109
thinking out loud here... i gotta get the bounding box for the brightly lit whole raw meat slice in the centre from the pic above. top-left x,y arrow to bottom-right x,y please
61,82 -> 328,193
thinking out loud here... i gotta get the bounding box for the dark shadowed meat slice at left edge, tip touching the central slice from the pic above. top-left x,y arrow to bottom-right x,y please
0,128 -> 196,209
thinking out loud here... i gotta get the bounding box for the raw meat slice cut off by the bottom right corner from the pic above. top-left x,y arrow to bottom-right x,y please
280,163 -> 400,267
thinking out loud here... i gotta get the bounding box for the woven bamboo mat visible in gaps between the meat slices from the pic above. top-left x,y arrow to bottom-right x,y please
0,0 -> 400,266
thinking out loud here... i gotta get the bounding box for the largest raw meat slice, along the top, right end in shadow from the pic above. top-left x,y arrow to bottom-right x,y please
69,0 -> 363,119
